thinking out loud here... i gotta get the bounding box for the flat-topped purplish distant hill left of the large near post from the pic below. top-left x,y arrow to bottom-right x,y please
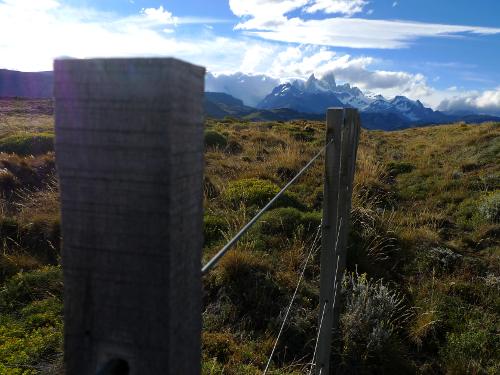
0,69 -> 54,99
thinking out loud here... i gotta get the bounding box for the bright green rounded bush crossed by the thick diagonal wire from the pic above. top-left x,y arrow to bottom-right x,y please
224,178 -> 304,209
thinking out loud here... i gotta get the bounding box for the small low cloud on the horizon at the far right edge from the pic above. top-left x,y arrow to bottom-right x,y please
438,87 -> 500,116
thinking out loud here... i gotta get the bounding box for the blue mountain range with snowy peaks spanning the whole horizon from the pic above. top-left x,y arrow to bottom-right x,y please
0,69 -> 500,130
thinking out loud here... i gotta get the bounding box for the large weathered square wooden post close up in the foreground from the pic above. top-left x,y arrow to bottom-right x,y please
54,59 -> 204,375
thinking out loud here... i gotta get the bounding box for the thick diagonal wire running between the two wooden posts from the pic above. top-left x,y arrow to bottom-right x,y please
201,140 -> 333,275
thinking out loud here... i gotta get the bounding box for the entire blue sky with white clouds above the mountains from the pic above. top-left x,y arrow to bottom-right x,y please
0,0 -> 500,113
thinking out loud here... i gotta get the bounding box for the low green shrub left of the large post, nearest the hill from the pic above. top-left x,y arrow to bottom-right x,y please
0,133 -> 54,156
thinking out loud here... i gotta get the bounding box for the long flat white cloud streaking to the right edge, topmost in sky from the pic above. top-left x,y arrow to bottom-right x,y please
229,0 -> 500,49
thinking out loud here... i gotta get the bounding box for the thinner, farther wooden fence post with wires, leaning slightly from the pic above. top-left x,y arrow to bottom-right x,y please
315,108 -> 360,375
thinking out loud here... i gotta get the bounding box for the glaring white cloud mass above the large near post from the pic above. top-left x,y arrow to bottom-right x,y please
0,0 -> 258,71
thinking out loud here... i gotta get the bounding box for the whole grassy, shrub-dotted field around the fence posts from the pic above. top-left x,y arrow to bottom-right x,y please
0,101 -> 500,375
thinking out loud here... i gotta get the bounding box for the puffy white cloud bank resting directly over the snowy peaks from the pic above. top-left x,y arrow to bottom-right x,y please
206,45 -> 443,106
